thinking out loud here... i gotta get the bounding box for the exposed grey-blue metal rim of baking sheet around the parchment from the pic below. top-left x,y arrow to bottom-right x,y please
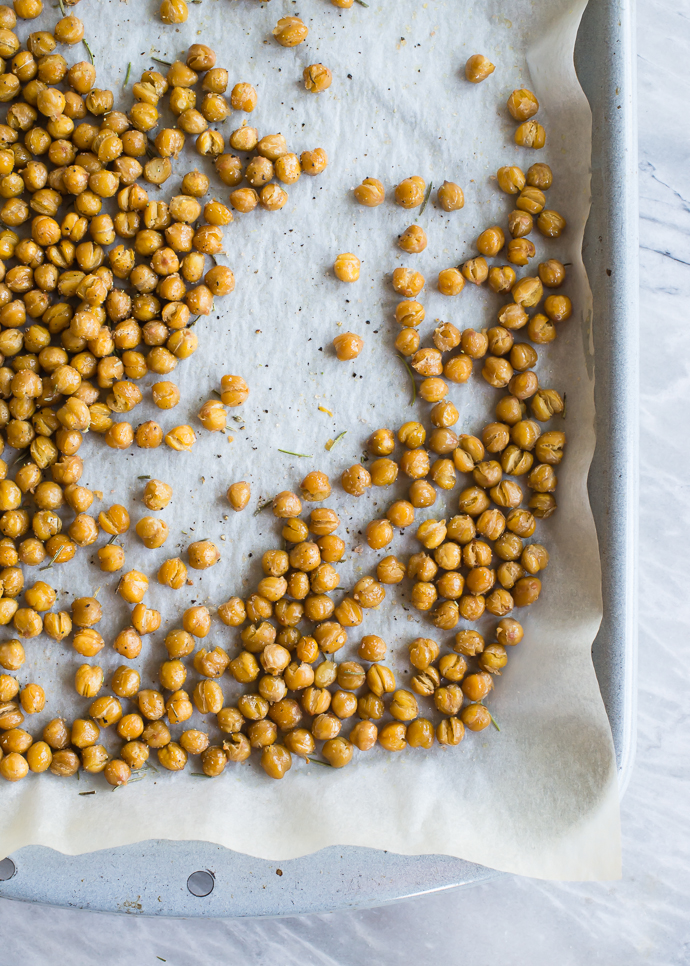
0,0 -> 639,918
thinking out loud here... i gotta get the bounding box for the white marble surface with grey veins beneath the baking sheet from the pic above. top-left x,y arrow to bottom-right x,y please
0,0 -> 690,966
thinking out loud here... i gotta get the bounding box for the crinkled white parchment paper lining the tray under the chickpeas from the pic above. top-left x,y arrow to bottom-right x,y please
0,0 -> 620,879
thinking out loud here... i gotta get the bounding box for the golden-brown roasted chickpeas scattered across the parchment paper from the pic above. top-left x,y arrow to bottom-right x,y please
0,26 -> 572,786
